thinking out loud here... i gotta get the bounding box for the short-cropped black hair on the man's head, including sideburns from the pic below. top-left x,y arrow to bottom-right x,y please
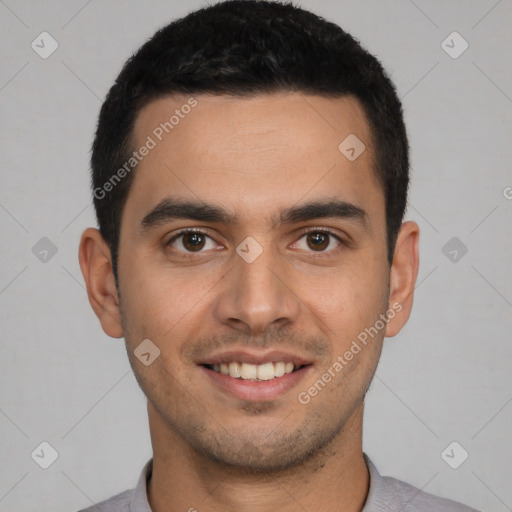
91,0 -> 409,283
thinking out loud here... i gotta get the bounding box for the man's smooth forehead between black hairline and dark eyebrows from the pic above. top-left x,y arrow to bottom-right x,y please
127,93 -> 383,228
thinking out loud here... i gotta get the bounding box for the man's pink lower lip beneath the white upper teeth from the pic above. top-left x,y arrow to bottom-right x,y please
200,365 -> 311,402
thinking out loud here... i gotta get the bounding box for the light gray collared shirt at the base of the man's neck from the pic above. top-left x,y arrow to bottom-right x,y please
79,455 -> 478,512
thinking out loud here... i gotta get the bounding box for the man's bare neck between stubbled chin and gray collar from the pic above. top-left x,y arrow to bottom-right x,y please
147,403 -> 369,512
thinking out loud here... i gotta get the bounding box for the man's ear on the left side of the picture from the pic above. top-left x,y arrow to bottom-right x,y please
78,228 -> 123,338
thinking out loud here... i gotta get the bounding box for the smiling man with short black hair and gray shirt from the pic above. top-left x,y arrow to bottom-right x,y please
80,0 -> 478,512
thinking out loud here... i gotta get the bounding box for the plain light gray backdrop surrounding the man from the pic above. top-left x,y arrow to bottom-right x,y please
0,0 -> 512,512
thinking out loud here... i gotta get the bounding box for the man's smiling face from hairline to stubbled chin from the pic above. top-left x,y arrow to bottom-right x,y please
79,94 -> 414,471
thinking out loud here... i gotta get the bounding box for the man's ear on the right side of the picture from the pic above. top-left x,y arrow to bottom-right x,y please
385,222 -> 420,337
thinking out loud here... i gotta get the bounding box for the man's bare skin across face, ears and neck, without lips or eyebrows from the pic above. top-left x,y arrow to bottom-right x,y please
79,93 -> 419,512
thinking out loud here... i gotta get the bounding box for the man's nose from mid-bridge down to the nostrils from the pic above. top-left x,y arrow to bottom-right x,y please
215,244 -> 301,335
